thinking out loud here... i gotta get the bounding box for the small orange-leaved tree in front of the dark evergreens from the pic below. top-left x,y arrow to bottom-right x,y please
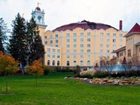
27,60 -> 44,87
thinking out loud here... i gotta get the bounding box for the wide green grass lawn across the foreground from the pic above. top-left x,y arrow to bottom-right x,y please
0,73 -> 140,105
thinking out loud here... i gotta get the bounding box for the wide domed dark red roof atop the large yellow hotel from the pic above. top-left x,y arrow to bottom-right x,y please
53,20 -> 118,31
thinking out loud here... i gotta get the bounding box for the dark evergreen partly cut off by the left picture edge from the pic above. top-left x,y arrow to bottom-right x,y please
0,18 -> 8,52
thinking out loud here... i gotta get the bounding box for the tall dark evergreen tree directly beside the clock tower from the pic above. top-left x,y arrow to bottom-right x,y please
27,18 -> 45,64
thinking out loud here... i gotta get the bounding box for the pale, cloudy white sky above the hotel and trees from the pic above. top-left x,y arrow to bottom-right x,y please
0,0 -> 140,31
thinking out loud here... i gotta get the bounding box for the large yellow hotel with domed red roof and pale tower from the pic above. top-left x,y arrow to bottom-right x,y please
32,7 -> 126,67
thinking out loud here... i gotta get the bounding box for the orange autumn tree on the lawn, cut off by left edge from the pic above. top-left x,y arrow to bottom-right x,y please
0,52 -> 18,93
